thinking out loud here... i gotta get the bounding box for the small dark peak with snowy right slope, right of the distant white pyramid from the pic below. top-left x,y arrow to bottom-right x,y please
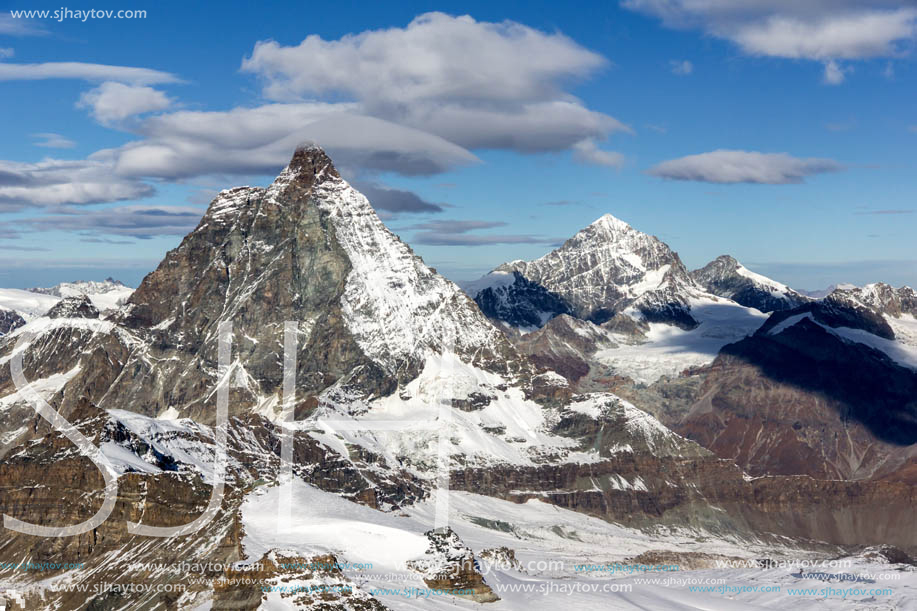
691,255 -> 808,312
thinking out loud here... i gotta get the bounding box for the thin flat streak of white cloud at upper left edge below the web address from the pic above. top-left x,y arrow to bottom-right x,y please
0,62 -> 180,85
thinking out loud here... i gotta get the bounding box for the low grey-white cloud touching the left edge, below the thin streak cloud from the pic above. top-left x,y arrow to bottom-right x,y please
0,159 -> 154,212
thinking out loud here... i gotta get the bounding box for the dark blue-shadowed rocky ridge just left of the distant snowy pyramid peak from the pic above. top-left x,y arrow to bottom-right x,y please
474,271 -> 570,327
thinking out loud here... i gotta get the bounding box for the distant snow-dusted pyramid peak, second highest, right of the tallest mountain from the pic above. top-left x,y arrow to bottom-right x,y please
473,214 -> 703,328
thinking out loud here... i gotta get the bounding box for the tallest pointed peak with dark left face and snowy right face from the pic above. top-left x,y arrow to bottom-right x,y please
59,149 -> 525,420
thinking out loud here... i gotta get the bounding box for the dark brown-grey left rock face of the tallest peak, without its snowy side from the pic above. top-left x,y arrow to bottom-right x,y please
109,152 -> 380,421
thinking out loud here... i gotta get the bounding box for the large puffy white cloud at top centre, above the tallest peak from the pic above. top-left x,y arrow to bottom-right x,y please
242,13 -> 606,103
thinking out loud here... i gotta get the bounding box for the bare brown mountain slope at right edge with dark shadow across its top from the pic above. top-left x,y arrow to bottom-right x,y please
675,318 -> 917,479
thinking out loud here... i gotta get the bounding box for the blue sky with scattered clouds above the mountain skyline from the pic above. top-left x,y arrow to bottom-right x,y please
0,0 -> 917,289
